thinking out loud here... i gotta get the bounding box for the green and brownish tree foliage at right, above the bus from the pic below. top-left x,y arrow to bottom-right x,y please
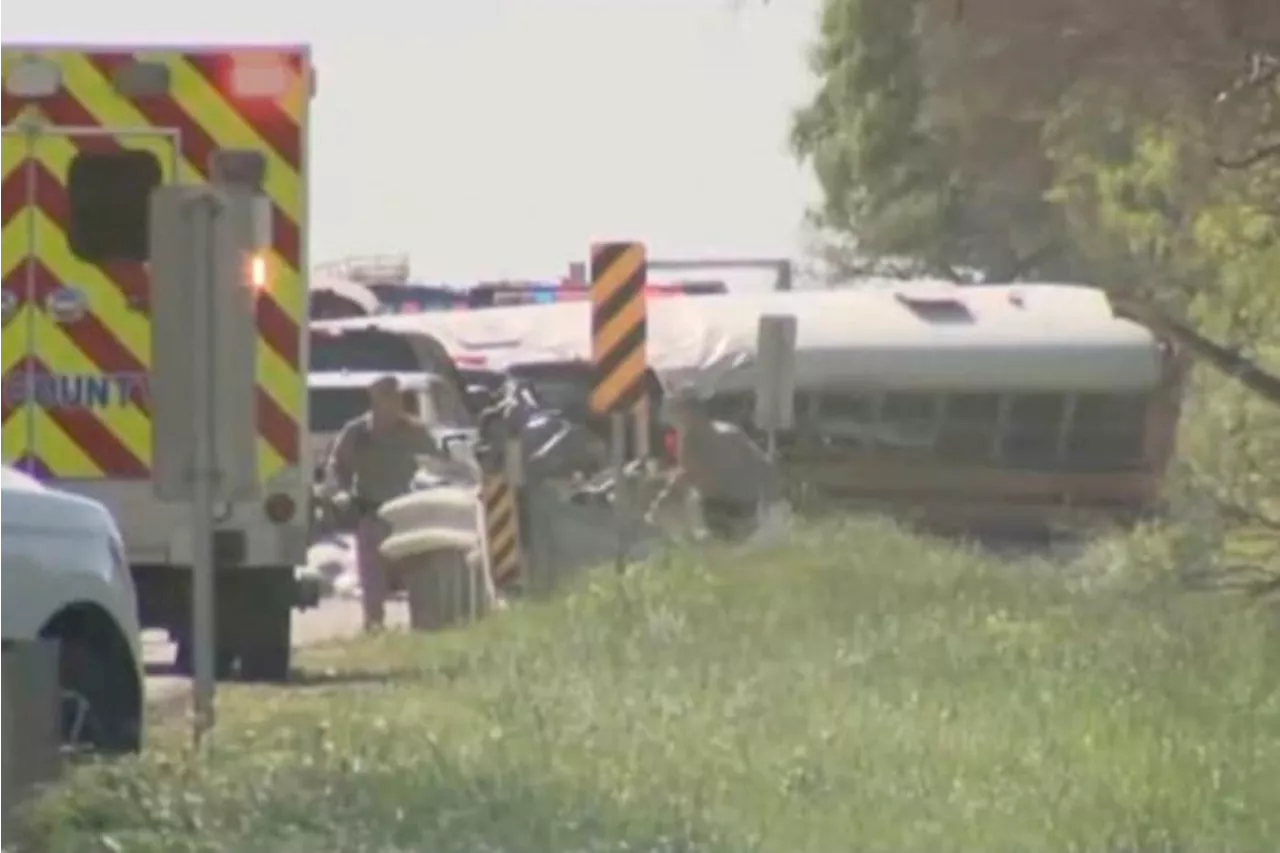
792,0 -> 1280,571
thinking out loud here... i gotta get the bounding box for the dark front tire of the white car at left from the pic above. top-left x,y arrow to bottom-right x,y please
58,638 -> 142,754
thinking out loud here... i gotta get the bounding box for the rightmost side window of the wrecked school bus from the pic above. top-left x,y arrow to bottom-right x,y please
1066,394 -> 1147,471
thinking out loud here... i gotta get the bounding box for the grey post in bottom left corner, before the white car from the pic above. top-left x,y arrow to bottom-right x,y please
0,640 -> 61,829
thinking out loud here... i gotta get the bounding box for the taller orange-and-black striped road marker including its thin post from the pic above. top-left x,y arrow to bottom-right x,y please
590,242 -> 649,573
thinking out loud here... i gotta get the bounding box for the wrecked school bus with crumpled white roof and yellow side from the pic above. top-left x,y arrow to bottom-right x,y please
314,282 -> 1184,533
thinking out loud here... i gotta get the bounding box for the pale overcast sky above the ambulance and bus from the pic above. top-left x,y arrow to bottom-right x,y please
4,0 -> 818,280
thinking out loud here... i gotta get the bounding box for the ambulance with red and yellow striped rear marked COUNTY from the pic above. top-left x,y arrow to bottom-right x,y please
0,42 -> 315,680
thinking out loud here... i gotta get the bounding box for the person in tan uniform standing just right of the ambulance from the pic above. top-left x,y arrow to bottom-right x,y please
326,375 -> 442,631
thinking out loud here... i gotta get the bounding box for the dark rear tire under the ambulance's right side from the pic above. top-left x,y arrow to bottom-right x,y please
236,566 -> 296,684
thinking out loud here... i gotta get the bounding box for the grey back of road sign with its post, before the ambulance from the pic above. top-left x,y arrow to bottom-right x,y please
151,186 -> 265,743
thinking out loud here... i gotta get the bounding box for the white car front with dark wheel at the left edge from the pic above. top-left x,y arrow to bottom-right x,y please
0,465 -> 145,753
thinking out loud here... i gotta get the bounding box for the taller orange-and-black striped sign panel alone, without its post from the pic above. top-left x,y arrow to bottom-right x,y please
590,242 -> 648,415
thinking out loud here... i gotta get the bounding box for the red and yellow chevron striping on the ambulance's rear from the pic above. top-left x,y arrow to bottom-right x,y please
0,46 -> 310,479
